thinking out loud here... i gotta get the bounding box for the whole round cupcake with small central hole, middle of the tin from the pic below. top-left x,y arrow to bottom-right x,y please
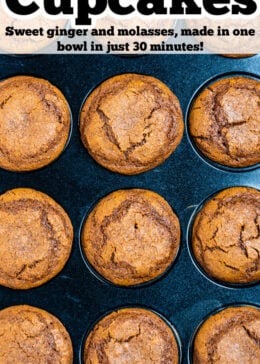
81,189 -> 180,286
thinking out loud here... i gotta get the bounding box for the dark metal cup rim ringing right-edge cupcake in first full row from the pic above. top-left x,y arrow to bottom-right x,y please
185,71 -> 260,172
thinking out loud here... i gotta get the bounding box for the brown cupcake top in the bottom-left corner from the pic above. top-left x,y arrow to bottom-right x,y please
0,305 -> 73,364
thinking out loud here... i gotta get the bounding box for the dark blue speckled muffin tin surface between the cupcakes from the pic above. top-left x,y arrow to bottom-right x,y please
0,54 -> 260,364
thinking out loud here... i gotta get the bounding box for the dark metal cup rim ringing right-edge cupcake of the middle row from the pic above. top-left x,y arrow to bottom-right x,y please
186,186 -> 260,289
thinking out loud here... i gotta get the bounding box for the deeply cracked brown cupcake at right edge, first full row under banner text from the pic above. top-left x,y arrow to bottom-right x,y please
189,76 -> 260,167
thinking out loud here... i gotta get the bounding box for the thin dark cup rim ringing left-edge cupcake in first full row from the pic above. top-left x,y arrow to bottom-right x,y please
0,74 -> 73,175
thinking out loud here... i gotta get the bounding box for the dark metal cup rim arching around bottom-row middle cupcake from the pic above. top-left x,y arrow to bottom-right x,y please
79,304 -> 183,364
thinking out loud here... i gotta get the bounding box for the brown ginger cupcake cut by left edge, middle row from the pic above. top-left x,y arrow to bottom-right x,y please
0,188 -> 73,289
